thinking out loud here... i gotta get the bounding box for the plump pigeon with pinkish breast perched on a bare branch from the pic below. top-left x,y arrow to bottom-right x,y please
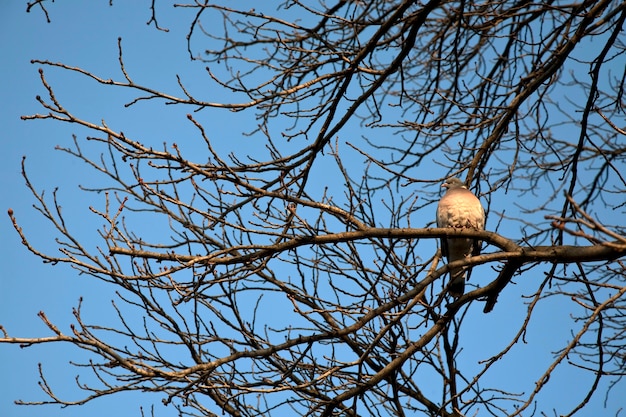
437,178 -> 485,297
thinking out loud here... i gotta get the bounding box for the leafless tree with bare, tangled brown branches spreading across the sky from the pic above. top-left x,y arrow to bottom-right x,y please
0,1 -> 626,416
